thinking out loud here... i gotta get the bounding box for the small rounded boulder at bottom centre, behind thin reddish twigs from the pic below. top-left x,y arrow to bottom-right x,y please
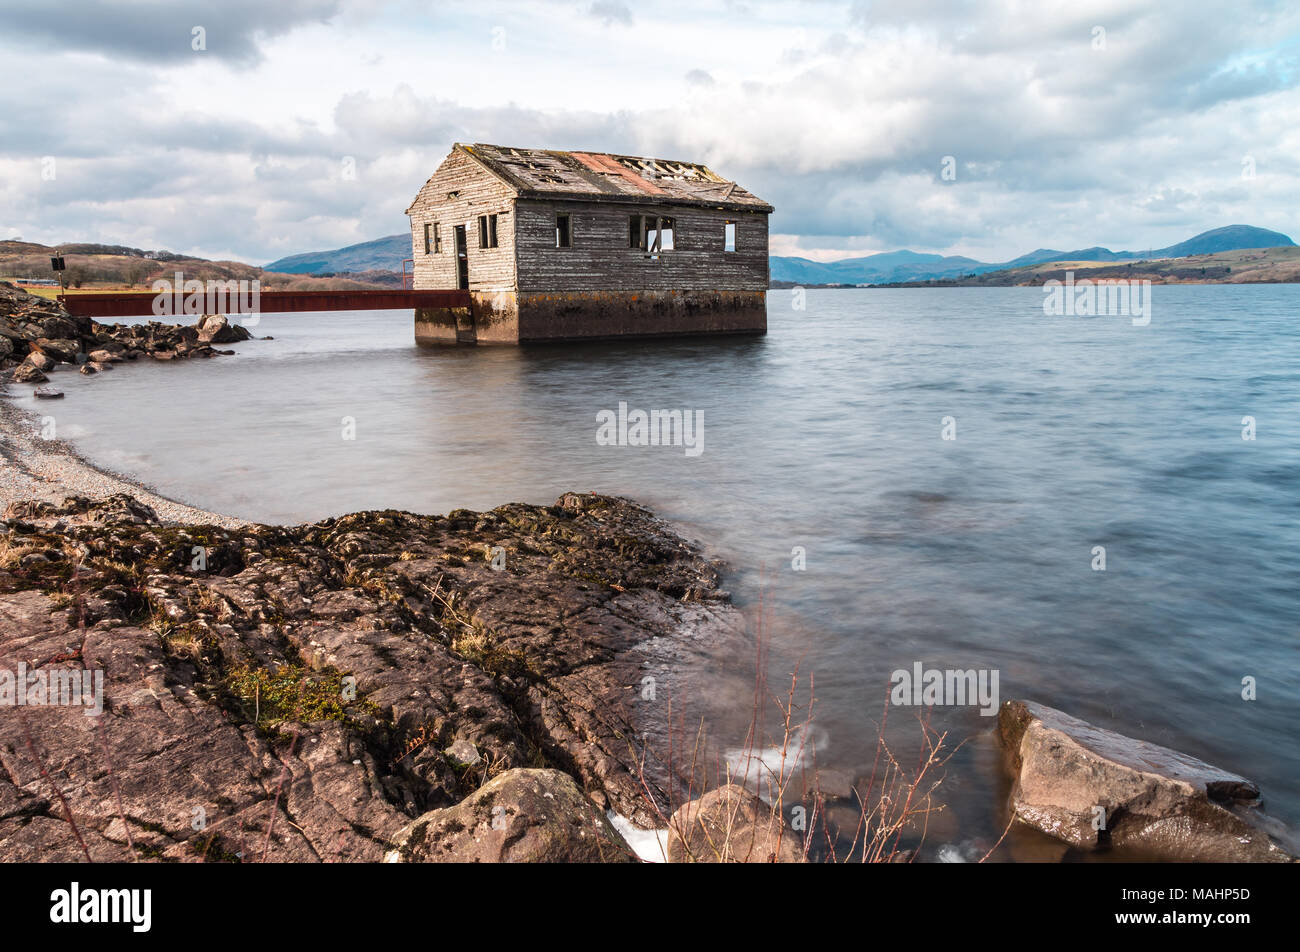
668,783 -> 803,862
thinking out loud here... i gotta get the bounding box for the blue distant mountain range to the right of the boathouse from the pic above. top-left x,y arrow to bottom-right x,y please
771,225 -> 1295,285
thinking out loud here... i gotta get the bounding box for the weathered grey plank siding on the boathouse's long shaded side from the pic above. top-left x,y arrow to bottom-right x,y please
514,199 -> 768,291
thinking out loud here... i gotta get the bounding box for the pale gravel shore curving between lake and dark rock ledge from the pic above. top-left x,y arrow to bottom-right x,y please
0,390 -> 247,529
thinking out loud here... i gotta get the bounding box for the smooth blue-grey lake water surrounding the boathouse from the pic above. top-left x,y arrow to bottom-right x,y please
14,286 -> 1300,858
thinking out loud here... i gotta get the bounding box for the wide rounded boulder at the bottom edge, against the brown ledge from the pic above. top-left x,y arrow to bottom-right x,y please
385,767 -> 636,862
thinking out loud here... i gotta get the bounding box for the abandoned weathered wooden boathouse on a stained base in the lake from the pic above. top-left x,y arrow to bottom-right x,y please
407,143 -> 772,343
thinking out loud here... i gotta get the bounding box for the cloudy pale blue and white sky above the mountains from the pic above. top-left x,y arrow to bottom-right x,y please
0,0 -> 1300,264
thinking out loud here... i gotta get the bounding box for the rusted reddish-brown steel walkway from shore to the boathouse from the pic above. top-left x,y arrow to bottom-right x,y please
59,289 -> 469,320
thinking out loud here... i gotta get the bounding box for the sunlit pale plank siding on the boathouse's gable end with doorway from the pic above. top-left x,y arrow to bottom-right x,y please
407,151 -> 515,291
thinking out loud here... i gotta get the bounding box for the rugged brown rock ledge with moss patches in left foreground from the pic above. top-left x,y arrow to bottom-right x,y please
0,493 -> 746,862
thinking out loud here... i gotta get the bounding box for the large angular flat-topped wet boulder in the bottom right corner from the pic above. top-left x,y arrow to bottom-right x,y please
998,701 -> 1294,862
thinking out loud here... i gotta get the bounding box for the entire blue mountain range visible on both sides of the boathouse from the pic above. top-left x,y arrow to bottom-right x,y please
265,225 -> 1295,285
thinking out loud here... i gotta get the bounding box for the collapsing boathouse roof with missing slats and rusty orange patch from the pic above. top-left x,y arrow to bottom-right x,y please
454,143 -> 772,212
